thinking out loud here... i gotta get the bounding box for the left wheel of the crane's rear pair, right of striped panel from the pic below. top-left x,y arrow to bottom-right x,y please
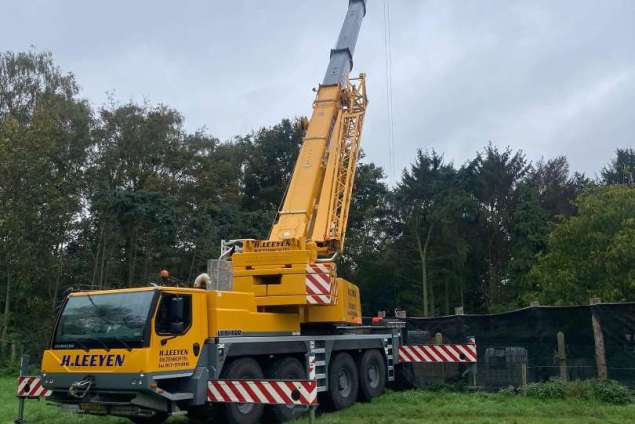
328,352 -> 359,411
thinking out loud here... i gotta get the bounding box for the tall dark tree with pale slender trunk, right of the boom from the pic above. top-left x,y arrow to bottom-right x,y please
393,151 -> 470,316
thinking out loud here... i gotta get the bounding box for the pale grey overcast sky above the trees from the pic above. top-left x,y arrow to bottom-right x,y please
0,0 -> 635,179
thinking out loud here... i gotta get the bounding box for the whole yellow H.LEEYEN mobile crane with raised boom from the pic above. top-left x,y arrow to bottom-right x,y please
31,0 -> 476,424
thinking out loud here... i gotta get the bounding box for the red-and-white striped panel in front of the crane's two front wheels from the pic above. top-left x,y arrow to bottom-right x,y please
207,380 -> 317,405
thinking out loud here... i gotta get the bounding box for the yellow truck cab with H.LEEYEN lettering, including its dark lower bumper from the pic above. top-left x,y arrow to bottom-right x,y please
41,287 -> 209,422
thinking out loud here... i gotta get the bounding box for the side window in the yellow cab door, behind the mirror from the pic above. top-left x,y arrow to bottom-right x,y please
155,293 -> 192,335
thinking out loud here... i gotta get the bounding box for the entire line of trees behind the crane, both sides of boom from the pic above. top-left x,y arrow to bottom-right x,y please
0,51 -> 635,356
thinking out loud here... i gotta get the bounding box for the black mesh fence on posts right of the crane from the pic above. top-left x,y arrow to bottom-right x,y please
407,303 -> 635,389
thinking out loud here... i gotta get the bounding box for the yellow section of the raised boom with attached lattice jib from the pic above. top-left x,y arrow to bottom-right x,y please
269,74 -> 367,254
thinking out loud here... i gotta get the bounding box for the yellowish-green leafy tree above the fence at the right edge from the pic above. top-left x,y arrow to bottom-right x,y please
530,185 -> 635,304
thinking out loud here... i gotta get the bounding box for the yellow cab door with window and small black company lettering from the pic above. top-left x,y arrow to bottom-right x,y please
150,290 -> 207,372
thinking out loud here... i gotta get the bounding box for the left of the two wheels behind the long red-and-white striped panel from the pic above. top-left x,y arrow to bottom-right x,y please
221,358 -> 264,424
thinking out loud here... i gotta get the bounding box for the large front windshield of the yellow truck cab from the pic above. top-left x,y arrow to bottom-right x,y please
53,291 -> 154,349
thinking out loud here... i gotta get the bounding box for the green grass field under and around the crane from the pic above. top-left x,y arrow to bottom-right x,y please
0,377 -> 635,424
